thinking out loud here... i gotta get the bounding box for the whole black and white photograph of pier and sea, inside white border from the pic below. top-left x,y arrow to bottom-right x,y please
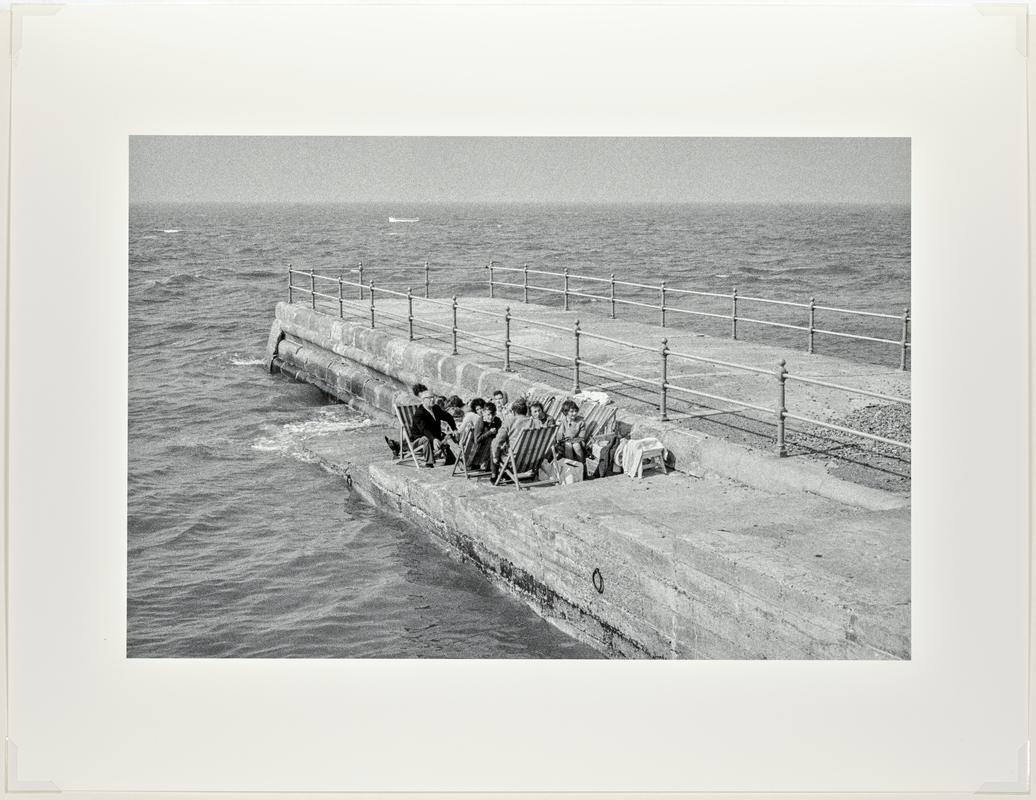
126,136 -> 923,660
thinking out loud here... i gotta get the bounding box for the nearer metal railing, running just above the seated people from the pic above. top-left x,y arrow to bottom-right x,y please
288,264 -> 911,456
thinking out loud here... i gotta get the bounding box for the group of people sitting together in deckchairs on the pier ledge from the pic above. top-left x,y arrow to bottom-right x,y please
385,383 -> 587,480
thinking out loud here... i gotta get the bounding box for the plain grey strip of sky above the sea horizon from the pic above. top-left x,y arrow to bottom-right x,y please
130,136 -> 910,203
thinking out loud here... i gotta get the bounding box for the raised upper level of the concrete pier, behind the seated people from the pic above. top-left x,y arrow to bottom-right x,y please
268,298 -> 910,510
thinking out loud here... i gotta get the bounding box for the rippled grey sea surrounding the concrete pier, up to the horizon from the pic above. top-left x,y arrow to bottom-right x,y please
126,203 -> 911,658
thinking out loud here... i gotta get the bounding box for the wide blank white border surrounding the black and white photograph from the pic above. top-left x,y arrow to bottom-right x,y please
5,5 -> 1031,796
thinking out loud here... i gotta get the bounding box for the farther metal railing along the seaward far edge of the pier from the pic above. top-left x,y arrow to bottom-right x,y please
486,261 -> 911,370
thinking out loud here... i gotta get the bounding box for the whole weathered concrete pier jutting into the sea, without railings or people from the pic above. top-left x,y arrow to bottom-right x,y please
269,298 -> 911,658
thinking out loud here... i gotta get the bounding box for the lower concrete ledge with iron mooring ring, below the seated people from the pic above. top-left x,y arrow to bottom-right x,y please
308,426 -> 910,659
